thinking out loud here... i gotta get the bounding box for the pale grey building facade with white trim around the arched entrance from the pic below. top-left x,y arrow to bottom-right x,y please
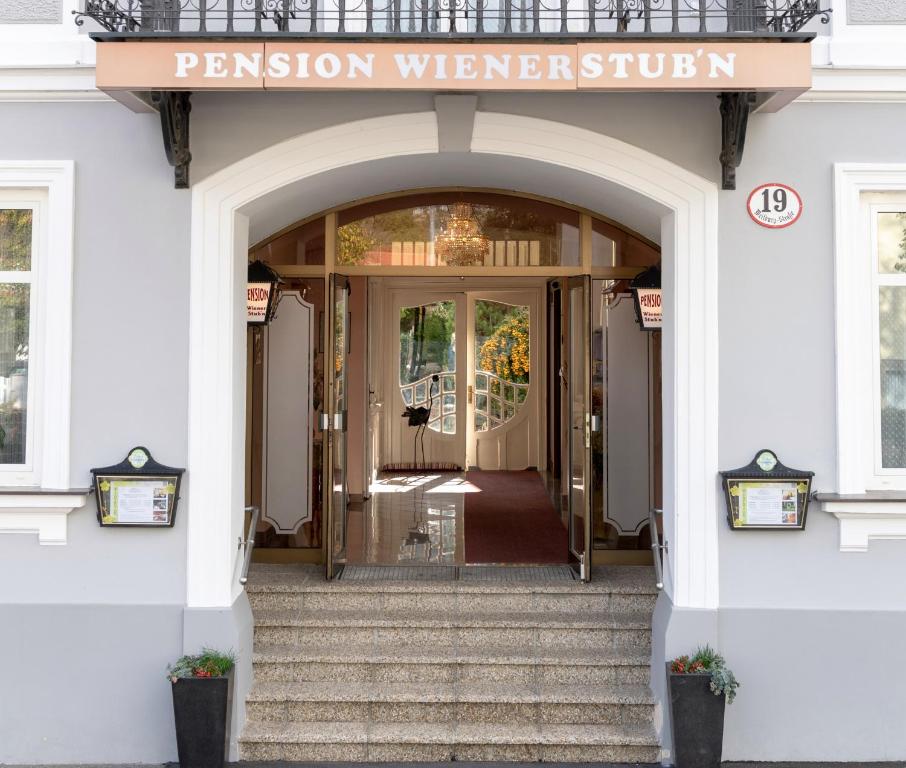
0,0 -> 906,764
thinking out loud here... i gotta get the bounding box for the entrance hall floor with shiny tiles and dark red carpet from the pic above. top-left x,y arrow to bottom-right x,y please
346,471 -> 567,565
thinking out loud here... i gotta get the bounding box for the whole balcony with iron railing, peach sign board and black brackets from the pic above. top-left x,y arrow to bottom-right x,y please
76,0 -> 830,189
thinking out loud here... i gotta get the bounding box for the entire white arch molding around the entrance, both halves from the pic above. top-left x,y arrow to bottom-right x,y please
187,112 -> 719,608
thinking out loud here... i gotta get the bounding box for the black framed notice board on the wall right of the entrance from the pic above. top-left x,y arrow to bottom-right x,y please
720,449 -> 815,531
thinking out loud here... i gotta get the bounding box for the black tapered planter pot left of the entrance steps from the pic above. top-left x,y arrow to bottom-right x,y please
171,670 -> 233,768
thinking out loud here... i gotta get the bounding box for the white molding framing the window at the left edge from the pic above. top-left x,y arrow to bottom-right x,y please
0,160 -> 75,490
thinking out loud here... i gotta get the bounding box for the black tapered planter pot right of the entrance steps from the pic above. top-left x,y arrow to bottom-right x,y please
667,664 -> 726,768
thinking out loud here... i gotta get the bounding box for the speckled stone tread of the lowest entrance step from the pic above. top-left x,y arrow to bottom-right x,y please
240,721 -> 658,747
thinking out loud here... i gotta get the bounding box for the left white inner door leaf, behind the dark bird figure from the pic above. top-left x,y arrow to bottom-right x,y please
383,291 -> 466,469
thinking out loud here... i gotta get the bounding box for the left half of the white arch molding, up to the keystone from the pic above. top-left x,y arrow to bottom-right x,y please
186,112 -> 438,608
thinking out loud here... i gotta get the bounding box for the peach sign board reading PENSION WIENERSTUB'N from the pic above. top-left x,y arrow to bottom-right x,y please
97,41 -> 811,92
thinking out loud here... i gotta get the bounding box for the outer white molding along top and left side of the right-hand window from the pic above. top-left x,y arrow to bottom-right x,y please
834,163 -> 906,494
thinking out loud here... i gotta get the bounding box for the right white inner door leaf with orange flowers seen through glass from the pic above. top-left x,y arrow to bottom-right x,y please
465,291 -> 541,470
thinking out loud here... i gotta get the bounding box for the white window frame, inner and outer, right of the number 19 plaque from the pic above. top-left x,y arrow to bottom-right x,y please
834,163 -> 906,494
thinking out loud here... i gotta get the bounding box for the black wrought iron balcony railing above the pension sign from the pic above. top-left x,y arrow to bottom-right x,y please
76,0 -> 830,38
